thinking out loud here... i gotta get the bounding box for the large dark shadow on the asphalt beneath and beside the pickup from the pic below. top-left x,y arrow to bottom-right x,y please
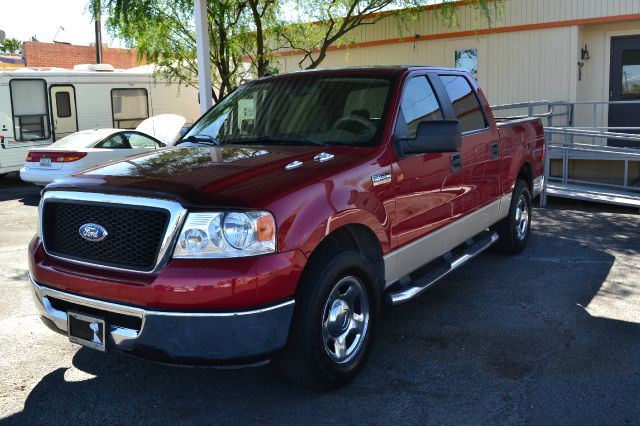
5,228 -> 640,424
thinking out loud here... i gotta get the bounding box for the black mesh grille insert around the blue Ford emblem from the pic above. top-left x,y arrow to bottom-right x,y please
42,200 -> 170,272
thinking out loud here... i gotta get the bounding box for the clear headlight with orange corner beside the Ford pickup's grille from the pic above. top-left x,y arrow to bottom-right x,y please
173,211 -> 276,258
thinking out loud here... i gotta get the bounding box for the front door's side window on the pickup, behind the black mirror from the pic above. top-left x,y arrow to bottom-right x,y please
401,76 -> 442,138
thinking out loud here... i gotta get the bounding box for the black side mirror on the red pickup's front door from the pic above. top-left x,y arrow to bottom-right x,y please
397,120 -> 462,155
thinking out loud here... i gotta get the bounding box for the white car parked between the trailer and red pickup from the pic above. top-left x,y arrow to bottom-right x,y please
20,115 -> 185,186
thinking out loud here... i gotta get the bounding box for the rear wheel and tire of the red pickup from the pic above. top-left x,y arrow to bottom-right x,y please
493,180 -> 531,254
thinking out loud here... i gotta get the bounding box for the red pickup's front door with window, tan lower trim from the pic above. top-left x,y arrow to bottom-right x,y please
393,75 -> 464,273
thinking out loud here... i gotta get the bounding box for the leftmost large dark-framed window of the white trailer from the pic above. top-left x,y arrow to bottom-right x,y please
9,79 -> 50,141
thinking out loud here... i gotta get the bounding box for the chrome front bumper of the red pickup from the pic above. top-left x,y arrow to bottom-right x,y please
30,277 -> 294,364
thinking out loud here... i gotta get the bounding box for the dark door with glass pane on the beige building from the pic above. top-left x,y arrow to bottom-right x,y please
608,36 -> 640,147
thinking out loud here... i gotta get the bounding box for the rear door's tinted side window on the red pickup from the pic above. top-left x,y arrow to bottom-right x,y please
440,75 -> 487,133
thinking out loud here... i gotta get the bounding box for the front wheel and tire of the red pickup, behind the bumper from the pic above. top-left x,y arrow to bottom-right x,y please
274,250 -> 380,390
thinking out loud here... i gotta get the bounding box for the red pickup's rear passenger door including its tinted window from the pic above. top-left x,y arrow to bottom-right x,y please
439,72 -> 501,223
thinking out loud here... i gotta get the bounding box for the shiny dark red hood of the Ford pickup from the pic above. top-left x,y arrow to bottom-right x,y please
46,146 -> 378,207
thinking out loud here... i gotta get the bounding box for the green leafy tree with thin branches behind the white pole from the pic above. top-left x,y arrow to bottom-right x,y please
97,0 -> 504,102
